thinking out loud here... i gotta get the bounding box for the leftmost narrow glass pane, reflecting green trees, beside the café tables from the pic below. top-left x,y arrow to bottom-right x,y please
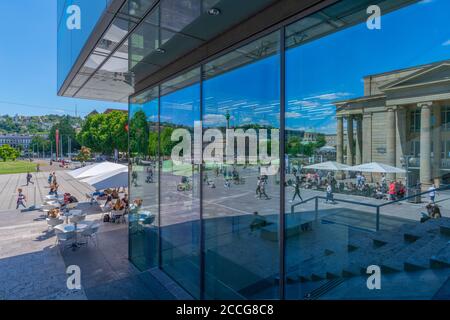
128,88 -> 160,270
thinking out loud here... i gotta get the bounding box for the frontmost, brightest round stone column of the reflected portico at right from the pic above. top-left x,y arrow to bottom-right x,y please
418,102 -> 432,190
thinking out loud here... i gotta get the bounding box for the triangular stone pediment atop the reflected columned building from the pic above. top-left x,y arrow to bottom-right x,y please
380,61 -> 450,92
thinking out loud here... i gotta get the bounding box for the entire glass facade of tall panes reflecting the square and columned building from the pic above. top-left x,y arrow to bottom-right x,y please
129,0 -> 450,299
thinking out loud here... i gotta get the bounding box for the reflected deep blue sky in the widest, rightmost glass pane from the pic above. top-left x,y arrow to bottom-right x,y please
286,0 -> 450,133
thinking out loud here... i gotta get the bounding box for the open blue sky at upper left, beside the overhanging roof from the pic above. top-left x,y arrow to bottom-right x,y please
0,0 -> 127,116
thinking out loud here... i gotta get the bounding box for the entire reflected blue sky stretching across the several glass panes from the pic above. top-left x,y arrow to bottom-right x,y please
130,0 -> 450,133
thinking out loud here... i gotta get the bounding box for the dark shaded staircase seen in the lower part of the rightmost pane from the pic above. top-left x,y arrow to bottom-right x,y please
287,218 -> 450,299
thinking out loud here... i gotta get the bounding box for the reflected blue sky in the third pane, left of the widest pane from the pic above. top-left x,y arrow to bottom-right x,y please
203,55 -> 280,127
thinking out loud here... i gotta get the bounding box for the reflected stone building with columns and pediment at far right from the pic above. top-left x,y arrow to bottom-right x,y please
335,61 -> 450,186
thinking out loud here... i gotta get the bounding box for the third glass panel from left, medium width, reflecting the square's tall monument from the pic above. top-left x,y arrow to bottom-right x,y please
202,33 -> 280,299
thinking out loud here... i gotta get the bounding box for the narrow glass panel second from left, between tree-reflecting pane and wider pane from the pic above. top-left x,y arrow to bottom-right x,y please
160,69 -> 201,298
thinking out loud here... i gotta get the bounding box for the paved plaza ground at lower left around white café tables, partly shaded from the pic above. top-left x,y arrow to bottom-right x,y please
0,171 -> 190,300
